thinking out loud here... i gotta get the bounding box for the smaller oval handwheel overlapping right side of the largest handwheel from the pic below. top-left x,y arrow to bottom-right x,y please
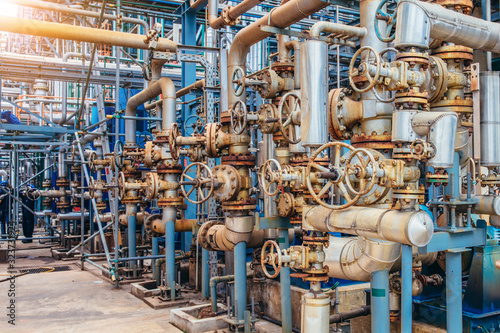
345,148 -> 377,196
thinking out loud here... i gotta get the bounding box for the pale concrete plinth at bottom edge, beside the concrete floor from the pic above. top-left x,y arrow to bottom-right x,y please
170,303 -> 227,333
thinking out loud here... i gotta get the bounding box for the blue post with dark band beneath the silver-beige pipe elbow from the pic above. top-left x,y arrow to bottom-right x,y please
370,269 -> 392,333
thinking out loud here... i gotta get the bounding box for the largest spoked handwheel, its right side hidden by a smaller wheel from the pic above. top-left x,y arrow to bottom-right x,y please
305,142 -> 361,210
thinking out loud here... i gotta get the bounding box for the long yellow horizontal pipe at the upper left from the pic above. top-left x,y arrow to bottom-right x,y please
0,16 -> 177,52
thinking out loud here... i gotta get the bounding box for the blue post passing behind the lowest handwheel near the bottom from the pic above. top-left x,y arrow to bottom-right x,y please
279,229 -> 292,333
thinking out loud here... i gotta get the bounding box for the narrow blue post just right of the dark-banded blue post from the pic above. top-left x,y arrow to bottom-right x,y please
401,244 -> 413,332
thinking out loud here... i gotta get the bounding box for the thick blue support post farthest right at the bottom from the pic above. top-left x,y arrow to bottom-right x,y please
446,250 -> 462,332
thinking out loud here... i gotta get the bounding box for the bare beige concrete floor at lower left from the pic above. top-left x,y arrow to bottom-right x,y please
0,241 -> 181,333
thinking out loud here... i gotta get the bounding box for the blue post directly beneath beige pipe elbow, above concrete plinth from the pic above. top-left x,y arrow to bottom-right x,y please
234,242 -> 247,320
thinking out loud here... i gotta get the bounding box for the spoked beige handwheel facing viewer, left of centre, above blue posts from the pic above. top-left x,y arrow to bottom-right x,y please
179,162 -> 214,204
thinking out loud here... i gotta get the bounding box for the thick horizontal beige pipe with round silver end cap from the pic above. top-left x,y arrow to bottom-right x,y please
302,206 -> 434,247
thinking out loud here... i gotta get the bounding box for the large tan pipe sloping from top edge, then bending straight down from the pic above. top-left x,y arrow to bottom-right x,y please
228,0 -> 329,107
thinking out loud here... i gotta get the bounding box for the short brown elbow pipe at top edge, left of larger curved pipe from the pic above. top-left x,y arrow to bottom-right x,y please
207,0 -> 263,29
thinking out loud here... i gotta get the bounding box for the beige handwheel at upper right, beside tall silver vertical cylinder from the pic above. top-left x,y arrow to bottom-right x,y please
349,46 -> 382,93
